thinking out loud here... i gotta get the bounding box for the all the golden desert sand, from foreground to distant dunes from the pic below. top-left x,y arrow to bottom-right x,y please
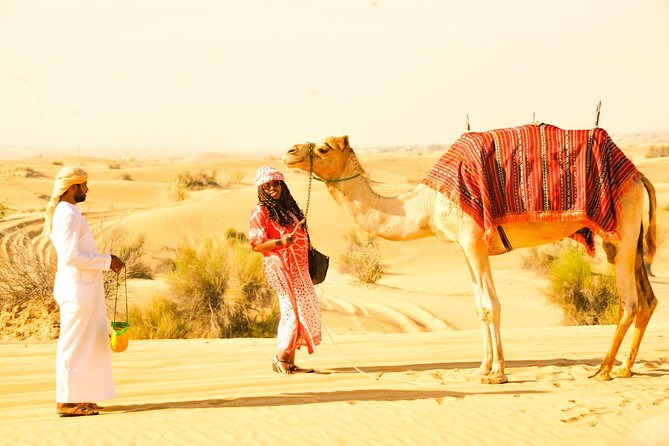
0,141 -> 669,446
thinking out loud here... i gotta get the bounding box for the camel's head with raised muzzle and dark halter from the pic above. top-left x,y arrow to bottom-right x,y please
283,136 -> 351,180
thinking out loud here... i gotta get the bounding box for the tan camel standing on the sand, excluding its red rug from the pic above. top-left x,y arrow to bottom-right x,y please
283,124 -> 657,384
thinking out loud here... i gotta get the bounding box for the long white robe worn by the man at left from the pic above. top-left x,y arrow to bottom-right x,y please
51,201 -> 114,403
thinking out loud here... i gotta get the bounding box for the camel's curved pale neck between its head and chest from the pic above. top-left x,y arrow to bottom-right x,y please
327,152 -> 434,240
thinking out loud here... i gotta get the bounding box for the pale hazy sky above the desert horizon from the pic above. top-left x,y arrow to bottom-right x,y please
0,0 -> 669,154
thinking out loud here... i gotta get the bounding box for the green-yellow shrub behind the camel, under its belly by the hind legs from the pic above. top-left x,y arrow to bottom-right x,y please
524,243 -> 618,325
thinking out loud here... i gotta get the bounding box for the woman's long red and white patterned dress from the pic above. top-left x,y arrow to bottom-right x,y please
249,204 -> 321,353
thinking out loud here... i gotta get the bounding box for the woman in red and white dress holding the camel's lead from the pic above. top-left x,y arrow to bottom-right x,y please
249,166 -> 321,375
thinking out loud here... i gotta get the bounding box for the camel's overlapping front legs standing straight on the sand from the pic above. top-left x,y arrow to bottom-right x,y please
461,239 -> 508,384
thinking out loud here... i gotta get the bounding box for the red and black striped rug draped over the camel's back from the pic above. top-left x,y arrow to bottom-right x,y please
423,124 -> 641,254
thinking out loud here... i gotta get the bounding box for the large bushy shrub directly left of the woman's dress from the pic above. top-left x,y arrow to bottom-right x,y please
168,237 -> 279,338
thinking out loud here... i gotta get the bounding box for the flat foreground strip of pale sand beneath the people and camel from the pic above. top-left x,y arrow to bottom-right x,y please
0,322 -> 669,446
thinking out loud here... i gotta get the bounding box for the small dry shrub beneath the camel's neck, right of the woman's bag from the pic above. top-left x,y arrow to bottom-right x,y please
340,229 -> 386,283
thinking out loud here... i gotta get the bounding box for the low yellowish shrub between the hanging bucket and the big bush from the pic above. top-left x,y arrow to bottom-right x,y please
128,296 -> 188,339
